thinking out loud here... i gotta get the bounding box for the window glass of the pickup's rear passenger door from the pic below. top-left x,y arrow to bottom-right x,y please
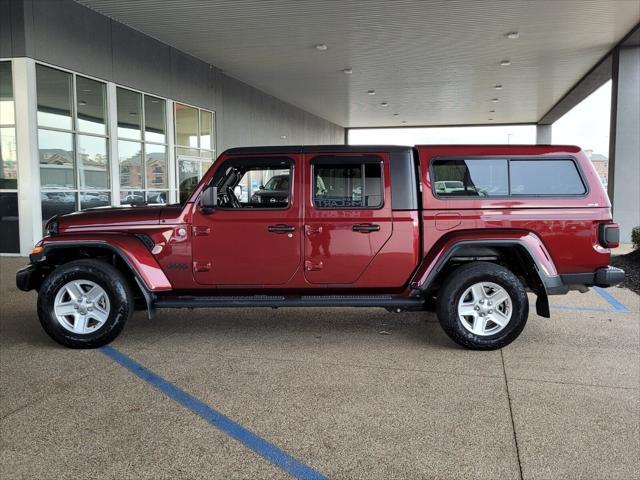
312,156 -> 383,209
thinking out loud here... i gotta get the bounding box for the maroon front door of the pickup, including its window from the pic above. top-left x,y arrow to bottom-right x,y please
192,155 -> 302,286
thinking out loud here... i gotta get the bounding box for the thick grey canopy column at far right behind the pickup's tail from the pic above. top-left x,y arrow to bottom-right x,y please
609,47 -> 640,243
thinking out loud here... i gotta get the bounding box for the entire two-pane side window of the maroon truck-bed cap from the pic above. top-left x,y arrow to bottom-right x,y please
432,158 -> 587,197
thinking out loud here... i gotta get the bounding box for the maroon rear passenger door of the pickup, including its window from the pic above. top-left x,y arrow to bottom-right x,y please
304,153 -> 393,284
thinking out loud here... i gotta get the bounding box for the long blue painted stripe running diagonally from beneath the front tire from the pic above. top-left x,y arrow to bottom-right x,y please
100,346 -> 327,480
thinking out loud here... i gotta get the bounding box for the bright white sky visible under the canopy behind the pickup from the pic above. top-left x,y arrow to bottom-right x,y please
349,81 -> 611,156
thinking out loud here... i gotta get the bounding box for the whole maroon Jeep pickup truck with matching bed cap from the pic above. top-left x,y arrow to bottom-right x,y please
16,145 -> 624,349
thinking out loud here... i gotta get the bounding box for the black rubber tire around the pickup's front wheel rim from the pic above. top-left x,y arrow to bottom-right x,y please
38,260 -> 134,348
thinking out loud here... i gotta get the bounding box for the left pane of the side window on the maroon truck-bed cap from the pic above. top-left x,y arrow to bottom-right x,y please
433,158 -> 509,197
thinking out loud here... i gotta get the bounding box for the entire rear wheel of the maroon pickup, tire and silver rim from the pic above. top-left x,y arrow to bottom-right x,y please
437,262 -> 529,350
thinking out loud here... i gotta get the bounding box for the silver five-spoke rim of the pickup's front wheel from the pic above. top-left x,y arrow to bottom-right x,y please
53,280 -> 111,335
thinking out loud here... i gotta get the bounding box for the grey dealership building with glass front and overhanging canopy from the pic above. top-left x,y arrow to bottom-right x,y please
0,0 -> 640,255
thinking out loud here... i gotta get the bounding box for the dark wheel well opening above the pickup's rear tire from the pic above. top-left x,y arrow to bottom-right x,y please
427,244 -> 545,296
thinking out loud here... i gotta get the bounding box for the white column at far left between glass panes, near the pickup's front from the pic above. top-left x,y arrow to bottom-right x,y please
13,58 -> 42,255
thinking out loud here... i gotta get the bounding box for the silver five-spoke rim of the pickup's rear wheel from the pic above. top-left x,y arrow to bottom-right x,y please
458,282 -> 513,337
